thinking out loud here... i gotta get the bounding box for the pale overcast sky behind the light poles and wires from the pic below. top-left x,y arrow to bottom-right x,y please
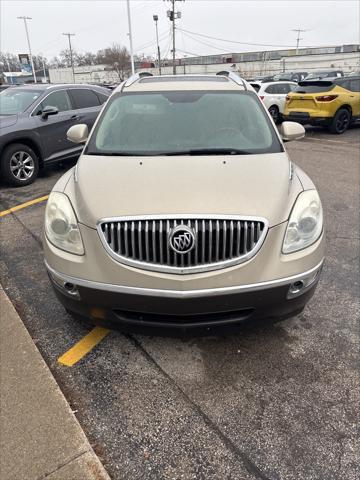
0,0 -> 360,58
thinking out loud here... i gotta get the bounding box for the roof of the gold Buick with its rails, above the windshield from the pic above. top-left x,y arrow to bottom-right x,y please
114,72 -> 253,93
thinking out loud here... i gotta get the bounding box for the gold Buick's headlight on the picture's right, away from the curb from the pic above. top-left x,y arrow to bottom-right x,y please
282,190 -> 323,253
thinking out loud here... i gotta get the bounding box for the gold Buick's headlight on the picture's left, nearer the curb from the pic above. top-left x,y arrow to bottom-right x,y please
45,192 -> 85,255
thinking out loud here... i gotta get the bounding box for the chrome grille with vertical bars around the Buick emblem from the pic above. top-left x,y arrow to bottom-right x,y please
98,215 -> 267,273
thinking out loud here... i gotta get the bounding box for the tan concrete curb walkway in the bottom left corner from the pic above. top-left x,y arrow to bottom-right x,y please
0,286 -> 110,480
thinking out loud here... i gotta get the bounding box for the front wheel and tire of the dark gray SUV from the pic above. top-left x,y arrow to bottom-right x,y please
1,143 -> 39,187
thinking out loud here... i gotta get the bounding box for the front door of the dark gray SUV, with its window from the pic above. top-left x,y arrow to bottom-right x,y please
31,89 -> 82,162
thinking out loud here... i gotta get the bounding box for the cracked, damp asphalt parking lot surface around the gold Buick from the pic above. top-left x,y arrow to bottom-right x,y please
0,128 -> 360,480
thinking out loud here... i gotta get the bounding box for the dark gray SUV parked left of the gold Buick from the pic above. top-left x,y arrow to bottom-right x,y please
0,84 -> 111,186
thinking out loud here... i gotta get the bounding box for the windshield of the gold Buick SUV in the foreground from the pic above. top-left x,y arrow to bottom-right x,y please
85,91 -> 283,155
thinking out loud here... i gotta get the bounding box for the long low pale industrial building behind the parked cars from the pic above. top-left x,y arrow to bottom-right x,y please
49,44 -> 360,83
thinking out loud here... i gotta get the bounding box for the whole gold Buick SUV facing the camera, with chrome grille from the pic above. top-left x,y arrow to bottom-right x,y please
43,72 -> 325,333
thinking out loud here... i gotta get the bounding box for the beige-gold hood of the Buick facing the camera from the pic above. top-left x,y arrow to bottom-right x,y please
65,153 -> 302,228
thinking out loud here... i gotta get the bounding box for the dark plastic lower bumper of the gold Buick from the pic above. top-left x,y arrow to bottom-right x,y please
49,275 -> 318,334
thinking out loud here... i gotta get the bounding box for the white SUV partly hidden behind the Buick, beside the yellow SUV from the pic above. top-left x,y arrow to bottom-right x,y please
251,82 -> 297,123
